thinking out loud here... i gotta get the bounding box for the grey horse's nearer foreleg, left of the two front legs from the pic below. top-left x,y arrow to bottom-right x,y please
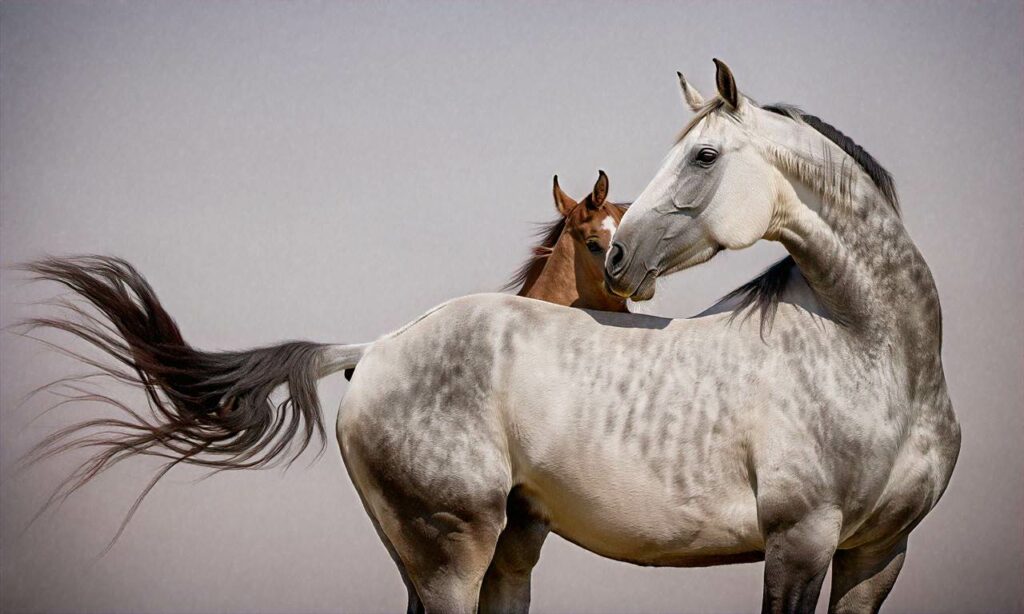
761,511 -> 841,614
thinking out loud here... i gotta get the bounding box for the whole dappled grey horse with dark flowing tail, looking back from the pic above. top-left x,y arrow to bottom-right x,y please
24,58 -> 959,613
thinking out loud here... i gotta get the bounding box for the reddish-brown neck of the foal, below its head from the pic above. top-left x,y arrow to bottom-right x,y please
519,232 -> 629,311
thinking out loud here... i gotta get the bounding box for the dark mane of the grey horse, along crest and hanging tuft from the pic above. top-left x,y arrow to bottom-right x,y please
720,103 -> 900,338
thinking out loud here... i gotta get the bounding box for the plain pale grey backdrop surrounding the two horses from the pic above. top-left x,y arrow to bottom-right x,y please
0,2 -> 1024,612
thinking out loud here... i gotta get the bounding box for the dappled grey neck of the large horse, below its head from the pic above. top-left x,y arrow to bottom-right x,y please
769,177 -> 941,352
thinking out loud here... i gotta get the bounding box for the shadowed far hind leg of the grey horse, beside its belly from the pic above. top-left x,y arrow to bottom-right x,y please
480,487 -> 548,614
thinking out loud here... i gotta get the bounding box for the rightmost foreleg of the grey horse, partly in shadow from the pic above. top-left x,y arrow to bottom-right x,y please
828,535 -> 906,614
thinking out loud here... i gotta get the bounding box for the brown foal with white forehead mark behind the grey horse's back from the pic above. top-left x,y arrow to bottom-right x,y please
505,171 -> 629,311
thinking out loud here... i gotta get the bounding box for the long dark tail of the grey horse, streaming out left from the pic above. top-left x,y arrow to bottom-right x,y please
18,256 -> 367,539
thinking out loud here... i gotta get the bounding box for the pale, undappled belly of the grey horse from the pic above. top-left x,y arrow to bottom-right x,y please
512,433 -> 762,566
